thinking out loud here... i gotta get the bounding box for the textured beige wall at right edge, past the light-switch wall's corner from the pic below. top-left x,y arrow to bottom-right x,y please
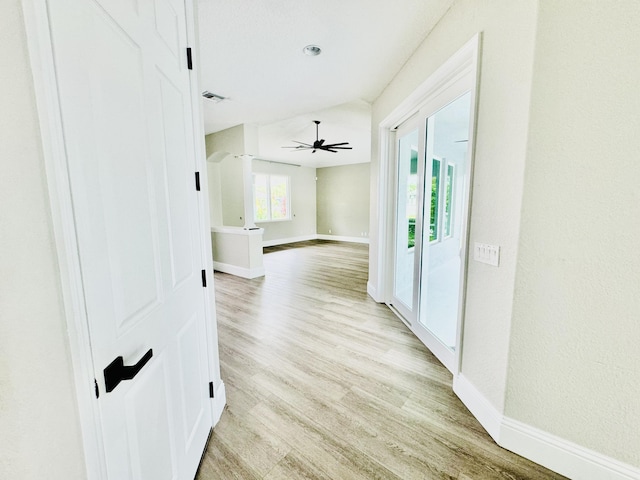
505,0 -> 640,467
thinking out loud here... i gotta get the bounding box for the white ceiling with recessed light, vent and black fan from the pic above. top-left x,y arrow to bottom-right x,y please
198,0 -> 454,167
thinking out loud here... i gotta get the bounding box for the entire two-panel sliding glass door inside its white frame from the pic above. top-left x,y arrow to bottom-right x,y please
391,92 -> 471,370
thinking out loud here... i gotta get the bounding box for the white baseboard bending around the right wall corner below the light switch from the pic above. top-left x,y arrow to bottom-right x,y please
453,374 -> 640,480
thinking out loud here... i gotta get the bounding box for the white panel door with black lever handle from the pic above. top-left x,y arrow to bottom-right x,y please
48,0 -> 212,480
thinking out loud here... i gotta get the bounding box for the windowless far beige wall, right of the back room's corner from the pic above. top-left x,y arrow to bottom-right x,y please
316,163 -> 371,238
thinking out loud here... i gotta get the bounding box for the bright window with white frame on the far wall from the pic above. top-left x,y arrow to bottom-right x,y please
253,173 -> 291,222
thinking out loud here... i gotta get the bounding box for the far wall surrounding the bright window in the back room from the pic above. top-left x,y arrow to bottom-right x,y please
253,160 -> 316,242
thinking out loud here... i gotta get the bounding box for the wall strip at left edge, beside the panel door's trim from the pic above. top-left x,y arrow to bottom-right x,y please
0,0 -> 86,480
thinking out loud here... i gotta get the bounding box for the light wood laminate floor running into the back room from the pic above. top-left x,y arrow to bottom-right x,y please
197,241 -> 564,480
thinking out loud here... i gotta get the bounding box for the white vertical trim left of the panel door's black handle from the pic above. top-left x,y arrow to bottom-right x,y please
22,0 -> 107,480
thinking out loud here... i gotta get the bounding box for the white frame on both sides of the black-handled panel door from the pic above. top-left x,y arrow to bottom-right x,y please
22,0 -> 226,480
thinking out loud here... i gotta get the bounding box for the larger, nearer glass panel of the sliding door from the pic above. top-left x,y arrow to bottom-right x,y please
418,93 -> 471,354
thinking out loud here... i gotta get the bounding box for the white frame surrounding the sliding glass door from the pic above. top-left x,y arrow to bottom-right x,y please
370,33 -> 481,376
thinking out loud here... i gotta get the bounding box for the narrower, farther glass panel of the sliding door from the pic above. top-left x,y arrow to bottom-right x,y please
393,128 -> 419,321
